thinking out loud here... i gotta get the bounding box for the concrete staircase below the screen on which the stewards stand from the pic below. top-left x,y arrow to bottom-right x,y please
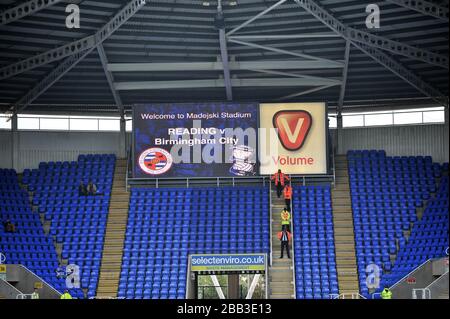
269,191 -> 295,299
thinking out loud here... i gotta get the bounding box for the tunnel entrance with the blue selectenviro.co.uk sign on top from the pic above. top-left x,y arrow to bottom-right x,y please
186,254 -> 268,299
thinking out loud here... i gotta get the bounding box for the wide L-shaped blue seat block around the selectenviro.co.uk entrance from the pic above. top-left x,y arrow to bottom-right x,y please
118,187 -> 270,299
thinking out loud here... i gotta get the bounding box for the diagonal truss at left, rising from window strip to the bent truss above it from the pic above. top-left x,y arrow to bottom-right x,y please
10,48 -> 94,114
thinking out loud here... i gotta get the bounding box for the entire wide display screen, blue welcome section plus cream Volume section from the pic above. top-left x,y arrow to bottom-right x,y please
133,103 -> 328,178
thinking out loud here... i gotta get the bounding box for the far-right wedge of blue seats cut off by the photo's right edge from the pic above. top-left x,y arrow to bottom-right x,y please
383,176 -> 449,286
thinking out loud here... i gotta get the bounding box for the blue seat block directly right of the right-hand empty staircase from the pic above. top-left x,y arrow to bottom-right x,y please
347,150 -> 441,297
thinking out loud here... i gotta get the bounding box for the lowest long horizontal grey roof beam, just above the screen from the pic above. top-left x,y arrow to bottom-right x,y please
115,78 -> 338,91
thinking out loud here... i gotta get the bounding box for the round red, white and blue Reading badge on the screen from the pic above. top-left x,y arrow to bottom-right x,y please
139,147 -> 173,175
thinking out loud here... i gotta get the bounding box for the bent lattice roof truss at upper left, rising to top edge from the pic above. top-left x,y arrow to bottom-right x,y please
0,0 -> 146,80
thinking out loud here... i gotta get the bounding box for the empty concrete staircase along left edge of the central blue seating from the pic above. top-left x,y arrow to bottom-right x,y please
97,159 -> 130,298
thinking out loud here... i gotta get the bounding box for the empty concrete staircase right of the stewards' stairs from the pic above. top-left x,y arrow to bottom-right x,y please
331,155 -> 359,294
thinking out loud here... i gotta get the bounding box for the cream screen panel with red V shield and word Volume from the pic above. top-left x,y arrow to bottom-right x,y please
259,103 -> 328,175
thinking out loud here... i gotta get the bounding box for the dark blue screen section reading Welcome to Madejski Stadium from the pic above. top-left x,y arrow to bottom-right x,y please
133,103 -> 259,178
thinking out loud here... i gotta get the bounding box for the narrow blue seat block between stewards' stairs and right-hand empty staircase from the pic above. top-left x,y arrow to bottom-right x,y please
293,186 -> 339,299
